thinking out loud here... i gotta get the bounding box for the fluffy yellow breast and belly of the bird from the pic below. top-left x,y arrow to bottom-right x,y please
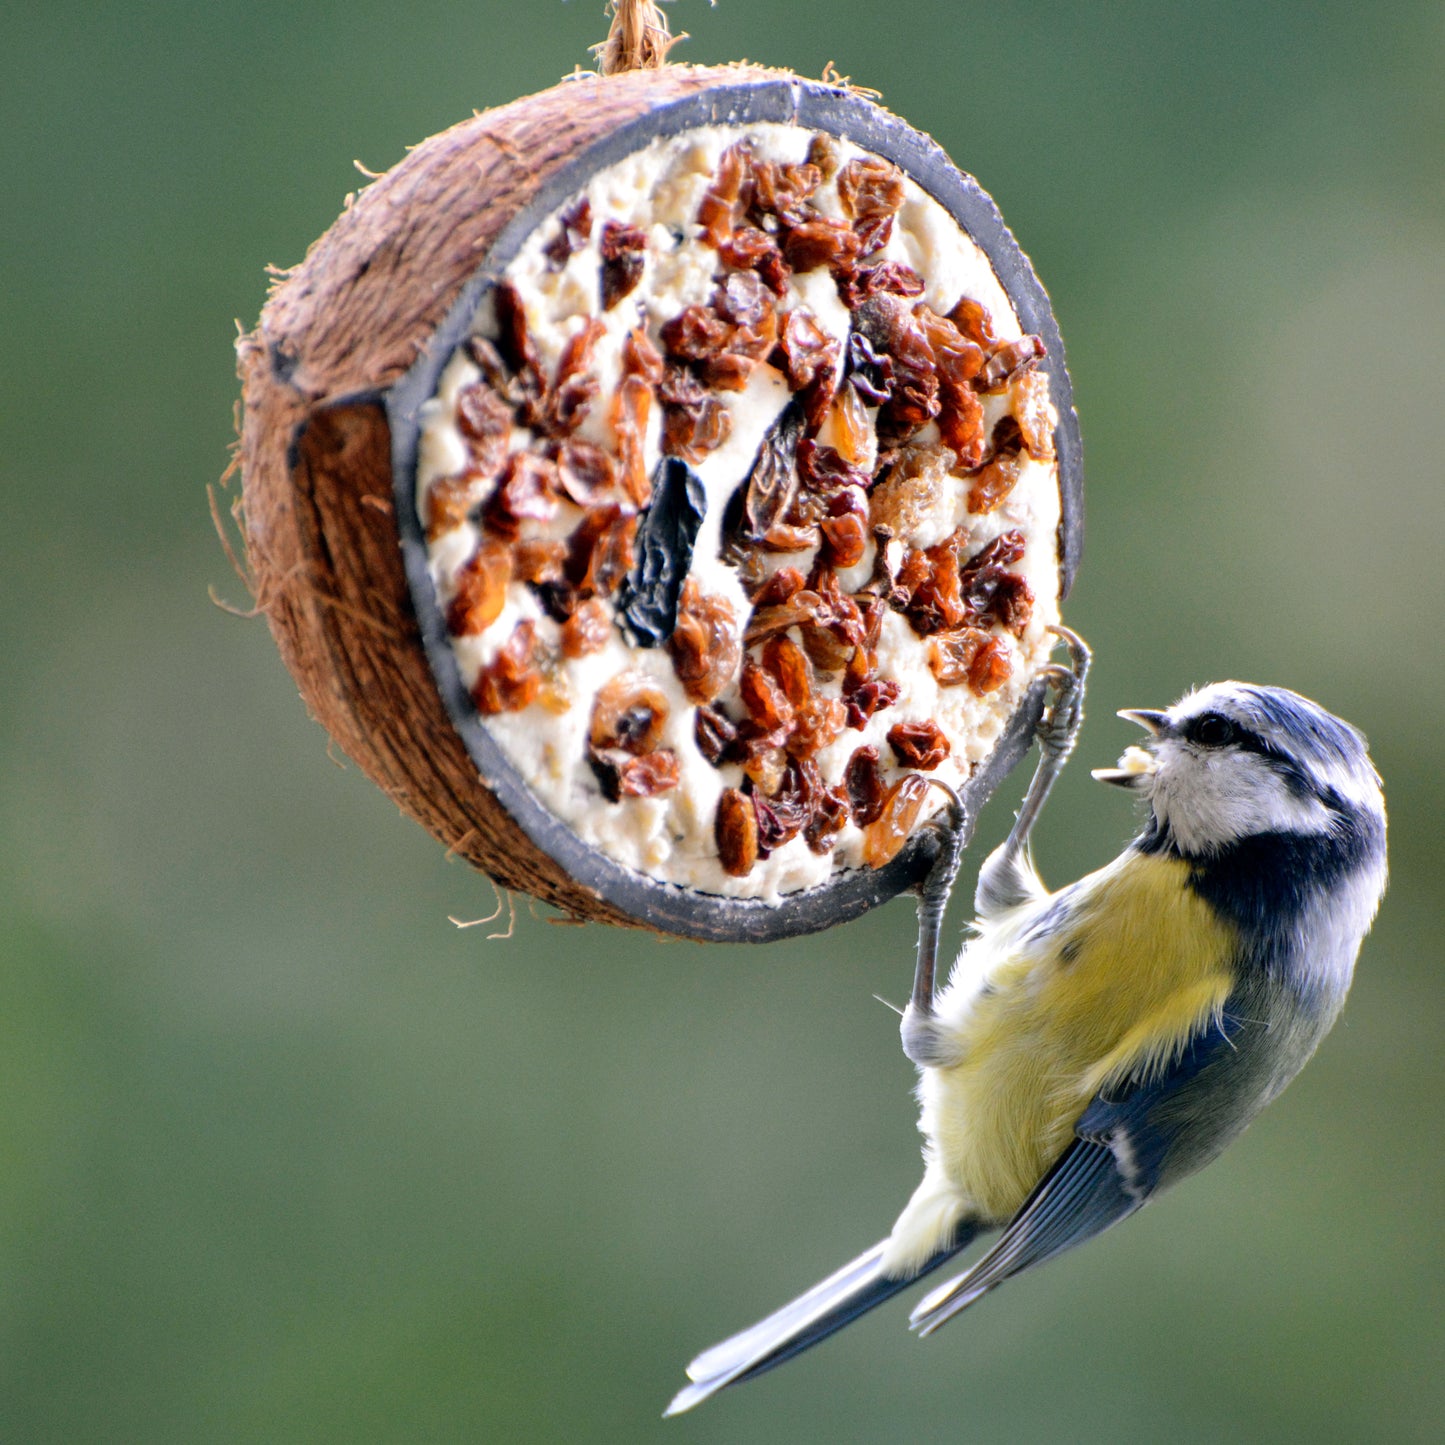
920,854 -> 1235,1220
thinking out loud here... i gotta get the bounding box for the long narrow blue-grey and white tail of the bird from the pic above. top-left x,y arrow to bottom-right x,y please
663,1224 -> 977,1415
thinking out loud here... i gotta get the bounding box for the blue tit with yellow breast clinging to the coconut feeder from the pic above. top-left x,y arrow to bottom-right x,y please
668,629 -> 1386,1415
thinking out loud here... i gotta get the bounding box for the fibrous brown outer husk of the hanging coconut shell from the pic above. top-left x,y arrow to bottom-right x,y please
237,65 -> 786,928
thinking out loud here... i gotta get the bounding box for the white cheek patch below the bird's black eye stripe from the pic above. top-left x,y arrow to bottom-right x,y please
1153,740 -> 1334,853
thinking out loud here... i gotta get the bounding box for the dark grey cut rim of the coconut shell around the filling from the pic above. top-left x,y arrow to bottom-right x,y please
386,79 -> 1082,944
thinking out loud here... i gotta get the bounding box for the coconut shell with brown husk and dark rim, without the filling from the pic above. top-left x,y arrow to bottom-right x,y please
238,66 -> 1082,941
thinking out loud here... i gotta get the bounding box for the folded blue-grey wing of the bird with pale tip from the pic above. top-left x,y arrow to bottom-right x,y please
910,1010 -> 1246,1335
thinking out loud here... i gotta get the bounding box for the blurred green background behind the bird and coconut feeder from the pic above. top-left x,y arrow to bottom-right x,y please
0,0 -> 1445,1442
